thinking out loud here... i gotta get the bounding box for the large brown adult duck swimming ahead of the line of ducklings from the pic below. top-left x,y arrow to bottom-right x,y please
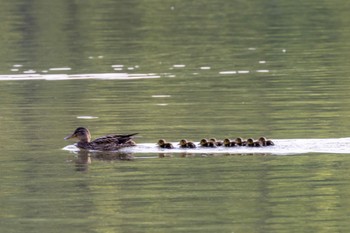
64,127 -> 137,151
